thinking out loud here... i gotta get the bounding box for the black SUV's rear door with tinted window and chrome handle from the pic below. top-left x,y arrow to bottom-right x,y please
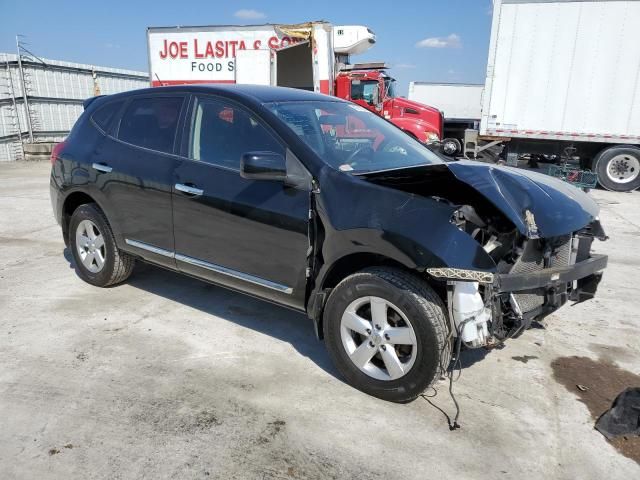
92,94 -> 185,266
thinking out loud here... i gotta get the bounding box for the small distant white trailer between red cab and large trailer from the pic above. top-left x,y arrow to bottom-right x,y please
408,82 -> 484,155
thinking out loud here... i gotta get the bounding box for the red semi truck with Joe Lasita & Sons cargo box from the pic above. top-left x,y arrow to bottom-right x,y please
147,22 -> 444,143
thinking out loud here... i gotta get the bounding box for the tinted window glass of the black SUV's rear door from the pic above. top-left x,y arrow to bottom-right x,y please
118,97 -> 183,153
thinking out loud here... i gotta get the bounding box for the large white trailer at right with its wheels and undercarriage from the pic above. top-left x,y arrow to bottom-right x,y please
464,0 -> 640,191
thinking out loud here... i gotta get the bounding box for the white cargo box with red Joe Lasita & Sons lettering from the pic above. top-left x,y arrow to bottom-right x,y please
147,22 -> 334,94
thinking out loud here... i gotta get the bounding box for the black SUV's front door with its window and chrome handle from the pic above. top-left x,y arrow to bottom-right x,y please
173,96 -> 310,308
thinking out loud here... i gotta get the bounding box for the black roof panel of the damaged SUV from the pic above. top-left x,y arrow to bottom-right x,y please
101,84 -> 344,103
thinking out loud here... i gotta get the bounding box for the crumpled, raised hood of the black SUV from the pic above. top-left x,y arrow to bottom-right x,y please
447,160 -> 599,238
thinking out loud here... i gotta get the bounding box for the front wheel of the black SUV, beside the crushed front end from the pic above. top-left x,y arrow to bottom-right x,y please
323,267 -> 451,402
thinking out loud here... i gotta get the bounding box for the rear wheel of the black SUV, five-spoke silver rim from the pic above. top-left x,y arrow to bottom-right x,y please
69,203 -> 135,287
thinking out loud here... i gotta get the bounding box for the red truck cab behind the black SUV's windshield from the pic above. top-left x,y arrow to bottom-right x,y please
335,68 -> 444,143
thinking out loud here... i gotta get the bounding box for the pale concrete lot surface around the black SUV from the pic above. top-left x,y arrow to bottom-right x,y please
0,162 -> 640,479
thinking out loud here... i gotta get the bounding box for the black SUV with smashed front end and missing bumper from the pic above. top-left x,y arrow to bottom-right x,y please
51,86 -> 607,402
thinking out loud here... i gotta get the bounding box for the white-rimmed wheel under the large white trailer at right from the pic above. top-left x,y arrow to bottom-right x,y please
594,146 -> 640,192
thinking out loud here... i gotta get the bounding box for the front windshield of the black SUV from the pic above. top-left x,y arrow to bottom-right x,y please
265,101 -> 442,173
